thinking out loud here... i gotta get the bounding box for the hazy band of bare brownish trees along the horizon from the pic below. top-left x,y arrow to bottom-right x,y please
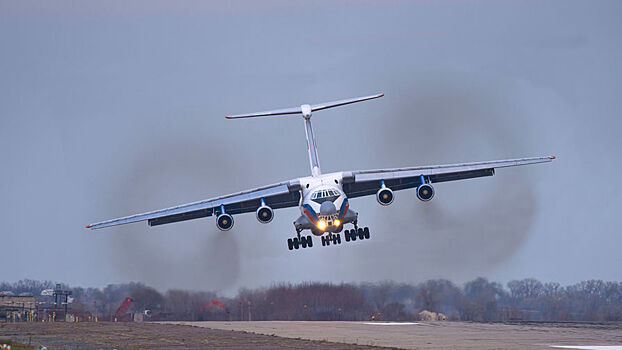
0,278 -> 622,322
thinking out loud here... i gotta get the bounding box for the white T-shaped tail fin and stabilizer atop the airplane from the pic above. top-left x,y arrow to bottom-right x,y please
225,94 -> 384,176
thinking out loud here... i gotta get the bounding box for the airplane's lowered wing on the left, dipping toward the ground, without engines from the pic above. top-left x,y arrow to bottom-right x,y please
86,179 -> 300,229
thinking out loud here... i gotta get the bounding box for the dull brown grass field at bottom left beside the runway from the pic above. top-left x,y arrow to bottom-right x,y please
0,322 -> 394,350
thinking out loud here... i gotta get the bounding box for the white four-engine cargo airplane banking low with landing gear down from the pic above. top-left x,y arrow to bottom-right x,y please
86,94 -> 555,250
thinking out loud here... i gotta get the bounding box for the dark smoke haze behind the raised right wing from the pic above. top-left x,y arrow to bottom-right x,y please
342,73 -> 537,281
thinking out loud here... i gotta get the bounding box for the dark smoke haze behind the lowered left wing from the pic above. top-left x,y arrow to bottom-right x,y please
103,135 -> 240,290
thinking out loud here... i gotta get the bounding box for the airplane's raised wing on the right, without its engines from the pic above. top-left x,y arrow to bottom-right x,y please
343,156 -> 555,198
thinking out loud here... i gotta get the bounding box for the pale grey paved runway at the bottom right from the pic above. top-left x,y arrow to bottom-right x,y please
168,321 -> 622,350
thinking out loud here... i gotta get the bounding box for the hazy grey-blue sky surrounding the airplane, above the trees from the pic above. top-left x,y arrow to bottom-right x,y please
0,1 -> 622,292
